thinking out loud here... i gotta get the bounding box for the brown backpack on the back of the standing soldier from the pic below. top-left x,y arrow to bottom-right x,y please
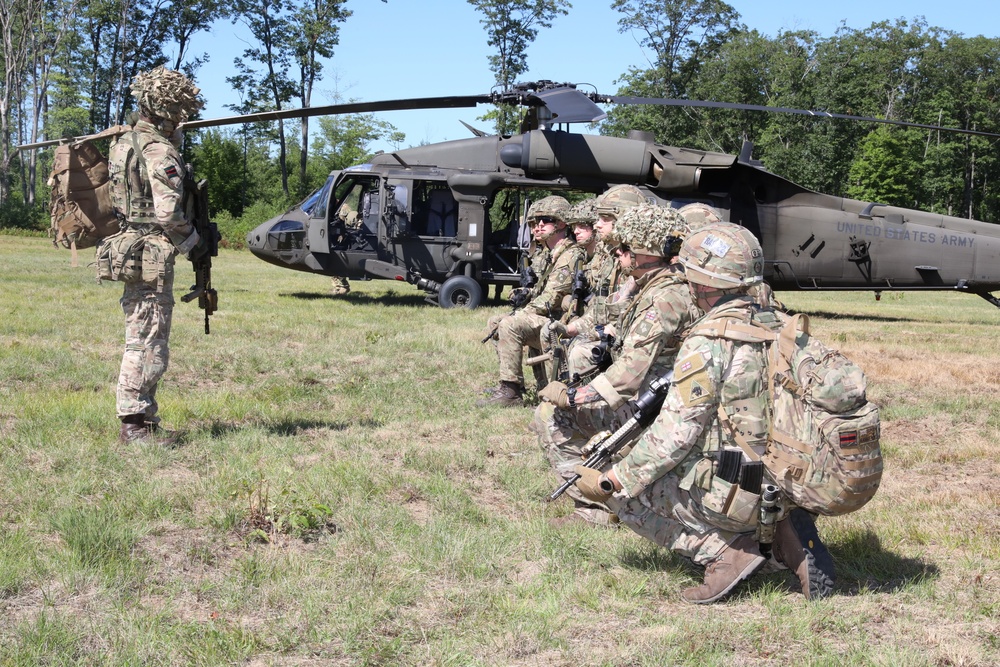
48,125 -> 129,265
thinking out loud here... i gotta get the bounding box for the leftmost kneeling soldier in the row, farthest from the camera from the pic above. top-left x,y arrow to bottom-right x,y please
476,196 -> 584,407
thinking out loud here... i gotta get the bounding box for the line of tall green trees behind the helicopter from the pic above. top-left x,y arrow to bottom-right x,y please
0,0 -> 1000,236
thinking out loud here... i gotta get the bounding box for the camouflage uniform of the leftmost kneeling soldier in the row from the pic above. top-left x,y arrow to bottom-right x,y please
497,238 -> 584,385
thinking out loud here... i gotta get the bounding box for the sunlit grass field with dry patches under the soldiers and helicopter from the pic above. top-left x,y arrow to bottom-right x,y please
0,236 -> 1000,667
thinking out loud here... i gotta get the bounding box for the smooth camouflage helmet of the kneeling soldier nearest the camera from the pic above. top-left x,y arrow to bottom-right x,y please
678,222 -> 764,290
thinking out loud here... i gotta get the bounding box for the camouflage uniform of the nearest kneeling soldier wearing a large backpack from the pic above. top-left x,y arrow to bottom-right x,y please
608,295 -> 779,565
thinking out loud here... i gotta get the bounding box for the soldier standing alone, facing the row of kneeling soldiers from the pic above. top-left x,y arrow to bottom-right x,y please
108,67 -> 209,444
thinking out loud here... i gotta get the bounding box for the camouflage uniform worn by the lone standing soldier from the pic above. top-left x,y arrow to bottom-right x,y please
108,120 -> 198,424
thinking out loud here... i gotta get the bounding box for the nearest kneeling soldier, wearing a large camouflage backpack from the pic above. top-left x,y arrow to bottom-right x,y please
576,223 -> 834,604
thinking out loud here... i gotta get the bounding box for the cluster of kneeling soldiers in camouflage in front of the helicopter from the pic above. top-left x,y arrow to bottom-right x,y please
479,185 -> 833,604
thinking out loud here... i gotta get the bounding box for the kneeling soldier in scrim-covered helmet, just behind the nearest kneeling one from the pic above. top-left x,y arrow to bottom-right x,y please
531,204 -> 701,525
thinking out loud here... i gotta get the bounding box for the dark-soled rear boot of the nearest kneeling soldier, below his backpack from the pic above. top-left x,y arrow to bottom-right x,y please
773,509 -> 834,600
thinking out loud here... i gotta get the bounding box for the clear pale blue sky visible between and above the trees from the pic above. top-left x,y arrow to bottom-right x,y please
182,0 -> 1000,150
